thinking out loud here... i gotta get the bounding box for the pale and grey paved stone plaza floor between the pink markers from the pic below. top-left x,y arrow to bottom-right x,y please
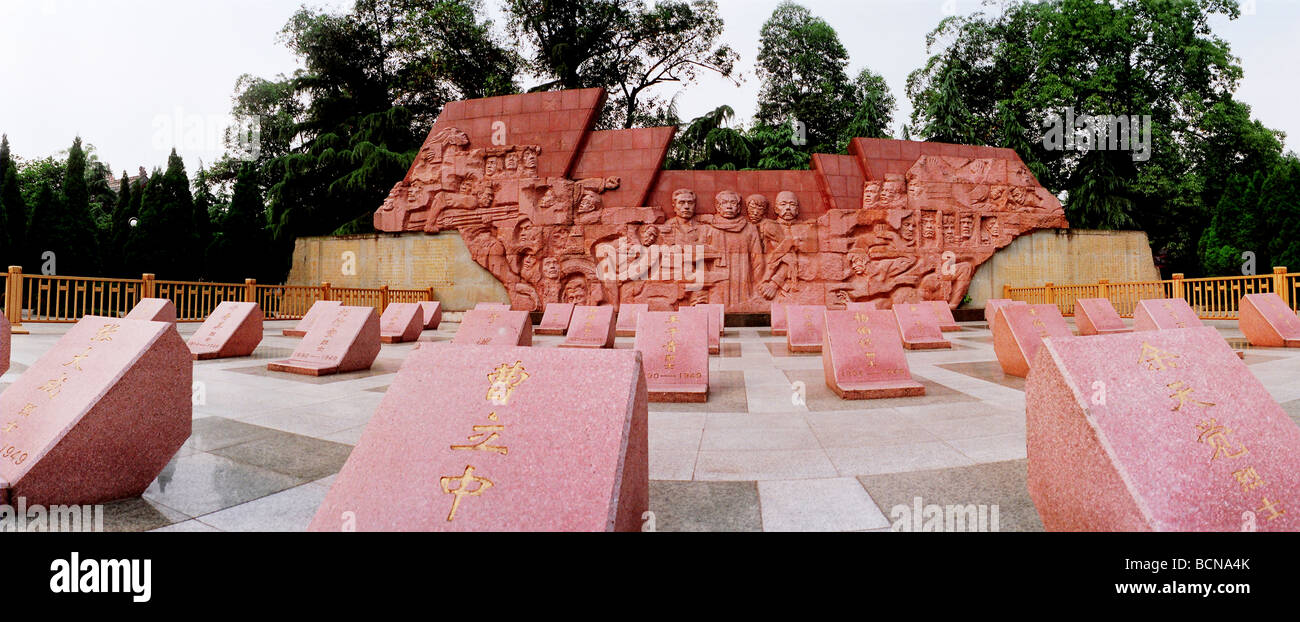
0,321 -> 1300,531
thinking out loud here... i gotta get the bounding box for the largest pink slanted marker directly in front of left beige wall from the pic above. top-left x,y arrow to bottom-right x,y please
267,306 -> 380,376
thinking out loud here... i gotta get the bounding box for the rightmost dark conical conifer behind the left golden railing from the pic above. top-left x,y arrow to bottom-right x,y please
208,164 -> 274,282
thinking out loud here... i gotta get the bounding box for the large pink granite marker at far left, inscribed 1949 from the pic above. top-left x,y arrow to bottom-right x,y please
0,315 -> 194,506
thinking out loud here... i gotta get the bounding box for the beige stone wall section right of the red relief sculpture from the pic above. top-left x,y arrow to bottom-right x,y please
966,229 -> 1160,308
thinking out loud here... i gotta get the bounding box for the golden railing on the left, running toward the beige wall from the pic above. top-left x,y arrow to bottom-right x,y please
0,265 -> 436,327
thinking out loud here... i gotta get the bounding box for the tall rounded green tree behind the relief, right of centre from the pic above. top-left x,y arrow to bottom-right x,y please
755,0 -> 859,154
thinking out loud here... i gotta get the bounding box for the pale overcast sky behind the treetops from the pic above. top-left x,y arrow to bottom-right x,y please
0,0 -> 1300,174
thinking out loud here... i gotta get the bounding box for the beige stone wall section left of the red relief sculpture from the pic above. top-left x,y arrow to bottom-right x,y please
289,233 -> 510,311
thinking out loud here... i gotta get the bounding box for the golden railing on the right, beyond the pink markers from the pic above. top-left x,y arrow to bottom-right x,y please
1002,267 -> 1300,320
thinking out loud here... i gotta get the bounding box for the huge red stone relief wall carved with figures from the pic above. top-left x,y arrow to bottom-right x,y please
374,88 -> 1069,312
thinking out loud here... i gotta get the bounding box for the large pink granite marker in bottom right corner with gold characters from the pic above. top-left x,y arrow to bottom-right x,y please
1024,327 -> 1300,531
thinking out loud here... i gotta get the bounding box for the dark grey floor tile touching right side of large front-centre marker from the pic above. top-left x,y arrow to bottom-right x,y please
650,481 -> 763,532
